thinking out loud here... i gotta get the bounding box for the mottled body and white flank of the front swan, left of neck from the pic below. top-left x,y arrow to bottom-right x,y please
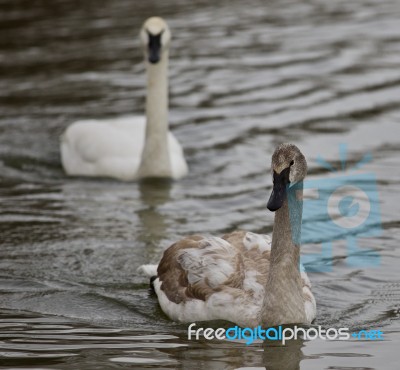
154,231 -> 270,326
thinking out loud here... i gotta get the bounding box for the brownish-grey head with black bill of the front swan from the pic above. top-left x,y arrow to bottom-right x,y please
267,143 -> 307,212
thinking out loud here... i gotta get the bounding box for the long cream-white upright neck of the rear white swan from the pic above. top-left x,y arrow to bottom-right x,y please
139,50 -> 172,177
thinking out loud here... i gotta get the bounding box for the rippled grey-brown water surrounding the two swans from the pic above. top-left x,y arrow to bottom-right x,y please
0,0 -> 400,369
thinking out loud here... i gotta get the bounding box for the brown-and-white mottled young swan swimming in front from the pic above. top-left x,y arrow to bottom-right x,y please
139,144 -> 316,327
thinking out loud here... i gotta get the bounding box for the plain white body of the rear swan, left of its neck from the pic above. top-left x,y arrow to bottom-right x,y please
61,116 -> 146,180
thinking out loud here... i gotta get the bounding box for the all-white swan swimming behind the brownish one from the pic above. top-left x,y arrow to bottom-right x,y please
61,17 -> 188,181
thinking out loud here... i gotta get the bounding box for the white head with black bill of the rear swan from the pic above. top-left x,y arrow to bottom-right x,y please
140,17 -> 171,64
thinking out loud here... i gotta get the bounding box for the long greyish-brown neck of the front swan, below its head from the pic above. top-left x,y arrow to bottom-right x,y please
261,184 -> 304,325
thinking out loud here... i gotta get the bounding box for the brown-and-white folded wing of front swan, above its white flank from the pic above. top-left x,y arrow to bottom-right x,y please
158,232 -> 269,303
